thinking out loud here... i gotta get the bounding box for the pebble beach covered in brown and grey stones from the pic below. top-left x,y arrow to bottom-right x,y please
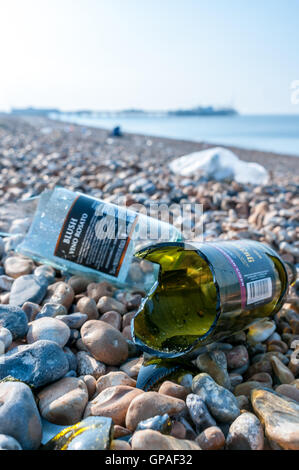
0,116 -> 299,451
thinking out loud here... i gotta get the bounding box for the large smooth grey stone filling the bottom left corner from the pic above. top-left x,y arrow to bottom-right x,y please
0,382 -> 42,450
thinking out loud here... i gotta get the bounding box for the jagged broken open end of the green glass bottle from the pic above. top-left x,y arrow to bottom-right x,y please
132,242 -> 220,358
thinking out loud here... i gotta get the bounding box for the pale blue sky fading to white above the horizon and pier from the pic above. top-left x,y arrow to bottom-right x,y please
0,0 -> 299,114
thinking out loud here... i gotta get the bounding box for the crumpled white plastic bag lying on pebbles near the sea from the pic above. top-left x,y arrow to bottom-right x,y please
169,147 -> 269,184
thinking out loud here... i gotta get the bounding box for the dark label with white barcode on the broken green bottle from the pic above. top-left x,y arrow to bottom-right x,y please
200,240 -> 275,310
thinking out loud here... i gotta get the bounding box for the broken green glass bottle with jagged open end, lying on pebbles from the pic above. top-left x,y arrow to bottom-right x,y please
132,240 -> 288,359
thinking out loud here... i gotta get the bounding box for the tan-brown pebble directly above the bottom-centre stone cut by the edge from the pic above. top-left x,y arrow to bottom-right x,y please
126,389 -> 186,430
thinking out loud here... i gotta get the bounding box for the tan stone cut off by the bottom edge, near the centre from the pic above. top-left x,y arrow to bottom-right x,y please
132,430 -> 200,450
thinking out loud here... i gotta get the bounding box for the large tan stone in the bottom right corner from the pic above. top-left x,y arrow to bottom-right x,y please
251,390 -> 299,450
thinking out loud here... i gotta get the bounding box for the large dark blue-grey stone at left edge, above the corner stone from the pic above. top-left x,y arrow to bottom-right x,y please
0,340 -> 69,387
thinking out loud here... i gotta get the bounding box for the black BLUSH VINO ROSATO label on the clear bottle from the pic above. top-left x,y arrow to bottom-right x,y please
54,195 -> 138,277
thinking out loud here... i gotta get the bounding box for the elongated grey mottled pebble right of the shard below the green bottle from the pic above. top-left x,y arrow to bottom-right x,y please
192,373 -> 240,423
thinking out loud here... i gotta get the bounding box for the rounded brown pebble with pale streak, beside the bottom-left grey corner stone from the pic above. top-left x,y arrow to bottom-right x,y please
37,377 -> 88,425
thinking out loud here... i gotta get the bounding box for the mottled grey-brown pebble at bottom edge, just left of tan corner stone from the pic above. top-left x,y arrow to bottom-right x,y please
226,412 -> 264,450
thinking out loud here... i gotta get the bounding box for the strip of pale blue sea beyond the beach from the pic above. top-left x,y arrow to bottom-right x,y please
51,113 -> 299,157
